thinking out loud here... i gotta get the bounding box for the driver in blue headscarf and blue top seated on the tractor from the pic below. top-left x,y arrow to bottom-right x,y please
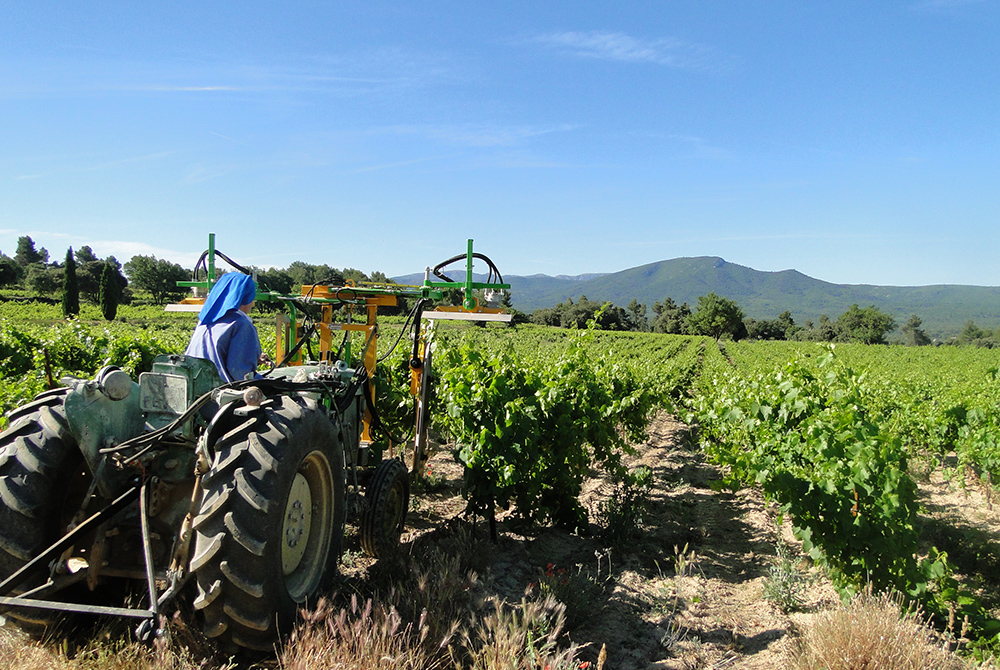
184,272 -> 262,382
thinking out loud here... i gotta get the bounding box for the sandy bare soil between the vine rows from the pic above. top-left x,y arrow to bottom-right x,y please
376,416 -> 1000,670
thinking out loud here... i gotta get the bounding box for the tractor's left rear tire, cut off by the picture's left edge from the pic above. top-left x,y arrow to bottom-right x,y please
0,389 -> 83,637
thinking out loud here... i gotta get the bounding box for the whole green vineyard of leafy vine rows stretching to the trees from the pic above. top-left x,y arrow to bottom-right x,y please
0,304 -> 1000,667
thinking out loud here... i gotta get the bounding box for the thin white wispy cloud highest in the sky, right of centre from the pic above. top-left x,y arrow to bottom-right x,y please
533,31 -> 726,70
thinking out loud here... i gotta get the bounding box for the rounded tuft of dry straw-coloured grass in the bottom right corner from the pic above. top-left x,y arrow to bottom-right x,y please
791,592 -> 969,670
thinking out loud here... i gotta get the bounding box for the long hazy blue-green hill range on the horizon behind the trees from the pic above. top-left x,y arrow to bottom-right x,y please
396,256 -> 1000,338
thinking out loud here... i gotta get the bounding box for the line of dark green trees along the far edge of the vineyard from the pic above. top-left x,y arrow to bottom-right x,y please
7,235 -> 1000,347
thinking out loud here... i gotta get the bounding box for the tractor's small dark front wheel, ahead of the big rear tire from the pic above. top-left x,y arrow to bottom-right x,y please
360,458 -> 410,558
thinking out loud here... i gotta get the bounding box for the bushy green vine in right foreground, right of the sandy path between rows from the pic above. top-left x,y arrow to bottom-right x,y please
691,353 -> 1000,635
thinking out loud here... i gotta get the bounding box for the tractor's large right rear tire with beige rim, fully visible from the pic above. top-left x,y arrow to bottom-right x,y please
190,396 -> 346,650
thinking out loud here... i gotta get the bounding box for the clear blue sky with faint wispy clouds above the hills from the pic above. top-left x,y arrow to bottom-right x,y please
0,0 -> 1000,286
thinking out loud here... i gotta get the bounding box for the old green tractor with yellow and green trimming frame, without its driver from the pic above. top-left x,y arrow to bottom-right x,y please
0,236 -> 509,649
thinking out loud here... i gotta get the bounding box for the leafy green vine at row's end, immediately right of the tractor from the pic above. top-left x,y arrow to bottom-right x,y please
435,333 -> 655,527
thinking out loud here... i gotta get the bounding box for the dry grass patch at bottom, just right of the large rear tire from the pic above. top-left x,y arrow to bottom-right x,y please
279,528 -> 579,670
